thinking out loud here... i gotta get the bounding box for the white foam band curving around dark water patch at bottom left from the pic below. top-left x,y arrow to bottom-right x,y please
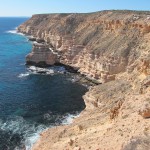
0,116 -> 47,150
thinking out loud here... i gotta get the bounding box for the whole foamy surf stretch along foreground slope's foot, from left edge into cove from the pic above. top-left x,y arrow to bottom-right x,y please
0,112 -> 79,150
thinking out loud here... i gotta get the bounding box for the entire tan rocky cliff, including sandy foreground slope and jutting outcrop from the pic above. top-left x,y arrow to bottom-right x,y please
18,11 -> 150,150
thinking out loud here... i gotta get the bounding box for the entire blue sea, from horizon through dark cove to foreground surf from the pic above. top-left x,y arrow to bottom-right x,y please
0,18 -> 86,150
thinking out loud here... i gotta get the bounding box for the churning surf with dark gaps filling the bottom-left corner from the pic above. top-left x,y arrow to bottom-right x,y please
0,116 -> 46,150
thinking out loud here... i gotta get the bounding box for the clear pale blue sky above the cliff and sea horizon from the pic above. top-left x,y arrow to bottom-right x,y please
0,0 -> 150,17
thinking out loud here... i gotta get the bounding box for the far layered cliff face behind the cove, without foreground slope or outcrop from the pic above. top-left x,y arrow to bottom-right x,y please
18,11 -> 150,83
